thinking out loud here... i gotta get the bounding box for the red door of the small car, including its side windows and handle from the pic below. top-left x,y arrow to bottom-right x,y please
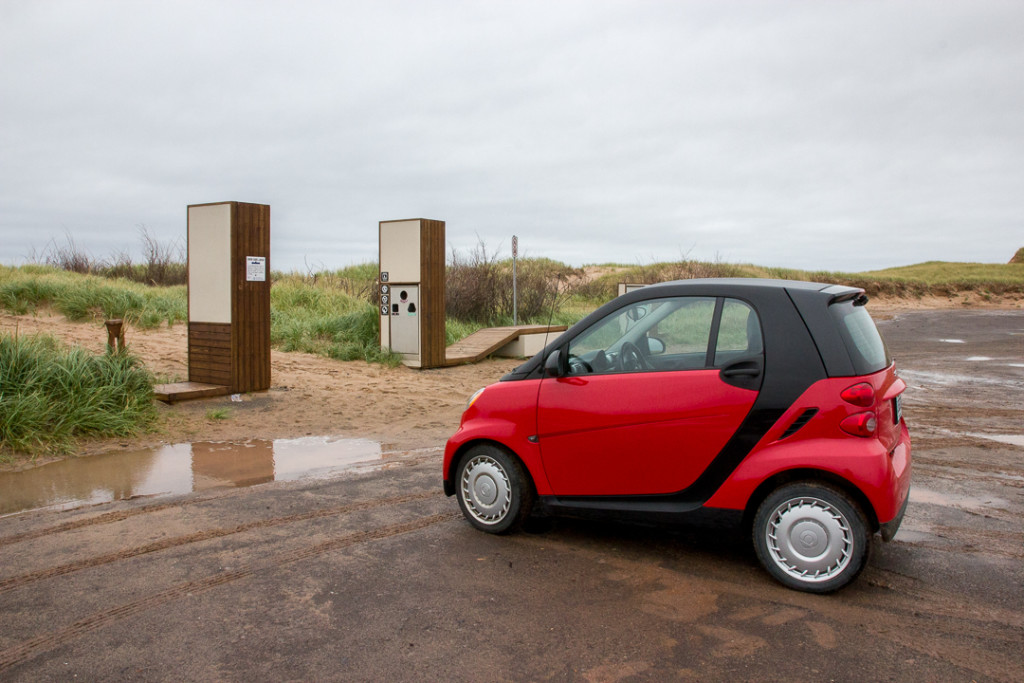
538,297 -> 763,496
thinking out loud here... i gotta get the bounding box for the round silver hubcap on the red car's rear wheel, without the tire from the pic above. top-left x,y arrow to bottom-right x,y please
765,497 -> 853,582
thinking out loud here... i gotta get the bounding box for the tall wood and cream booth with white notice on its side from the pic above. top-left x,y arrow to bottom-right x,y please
188,202 -> 270,395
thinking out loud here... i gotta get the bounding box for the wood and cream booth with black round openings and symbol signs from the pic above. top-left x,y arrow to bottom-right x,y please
379,218 -> 444,368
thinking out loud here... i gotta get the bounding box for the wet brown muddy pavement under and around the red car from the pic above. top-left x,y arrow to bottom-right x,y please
0,312 -> 1024,681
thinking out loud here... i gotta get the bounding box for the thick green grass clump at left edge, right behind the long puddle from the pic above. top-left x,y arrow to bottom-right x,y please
0,333 -> 157,460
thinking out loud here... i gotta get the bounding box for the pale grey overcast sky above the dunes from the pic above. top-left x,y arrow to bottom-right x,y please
0,0 -> 1024,270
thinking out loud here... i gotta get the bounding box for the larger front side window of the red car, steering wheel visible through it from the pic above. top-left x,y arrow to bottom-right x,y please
568,297 -> 715,375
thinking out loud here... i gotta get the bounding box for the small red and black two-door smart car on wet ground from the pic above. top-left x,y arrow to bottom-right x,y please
443,280 -> 910,593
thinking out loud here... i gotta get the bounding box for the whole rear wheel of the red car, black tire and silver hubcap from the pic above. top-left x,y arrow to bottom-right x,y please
753,481 -> 871,593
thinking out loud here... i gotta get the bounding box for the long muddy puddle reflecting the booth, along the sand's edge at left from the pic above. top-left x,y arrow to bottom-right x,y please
0,437 -> 383,515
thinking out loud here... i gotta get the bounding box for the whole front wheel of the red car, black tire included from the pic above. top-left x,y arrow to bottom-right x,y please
456,444 -> 535,533
